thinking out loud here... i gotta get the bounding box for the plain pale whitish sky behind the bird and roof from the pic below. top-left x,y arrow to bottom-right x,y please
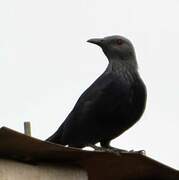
0,0 -> 179,169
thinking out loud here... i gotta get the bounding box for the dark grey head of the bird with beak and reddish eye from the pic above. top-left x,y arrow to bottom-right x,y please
87,35 -> 135,61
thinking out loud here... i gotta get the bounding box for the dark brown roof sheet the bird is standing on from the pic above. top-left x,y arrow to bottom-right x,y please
0,127 -> 179,180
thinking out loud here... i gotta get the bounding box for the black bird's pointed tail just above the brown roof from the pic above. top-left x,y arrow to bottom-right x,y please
45,124 -> 65,145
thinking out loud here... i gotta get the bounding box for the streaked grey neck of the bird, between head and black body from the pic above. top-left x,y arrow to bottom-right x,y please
106,58 -> 138,73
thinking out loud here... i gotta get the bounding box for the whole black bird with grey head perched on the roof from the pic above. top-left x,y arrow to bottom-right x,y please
47,36 -> 146,148
